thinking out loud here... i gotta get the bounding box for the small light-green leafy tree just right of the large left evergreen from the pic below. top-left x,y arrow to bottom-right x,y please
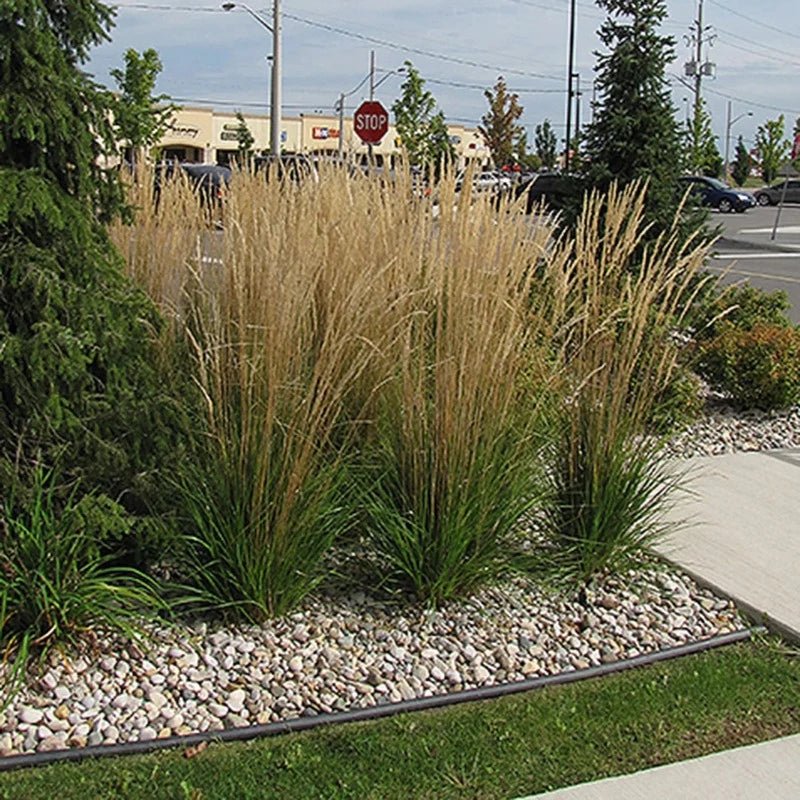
111,48 -> 178,162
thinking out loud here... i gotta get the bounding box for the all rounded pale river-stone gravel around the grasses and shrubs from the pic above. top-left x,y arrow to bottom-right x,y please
0,406 -> 800,755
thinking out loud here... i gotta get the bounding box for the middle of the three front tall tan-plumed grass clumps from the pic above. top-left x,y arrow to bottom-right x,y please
359,170 -> 557,605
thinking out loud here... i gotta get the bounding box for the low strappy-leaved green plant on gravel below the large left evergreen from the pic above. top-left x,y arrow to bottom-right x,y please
0,469 -> 163,700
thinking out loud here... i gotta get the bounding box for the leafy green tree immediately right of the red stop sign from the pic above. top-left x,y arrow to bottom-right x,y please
392,61 -> 455,171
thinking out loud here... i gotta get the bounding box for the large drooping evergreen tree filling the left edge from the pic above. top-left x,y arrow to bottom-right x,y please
0,0 -> 177,506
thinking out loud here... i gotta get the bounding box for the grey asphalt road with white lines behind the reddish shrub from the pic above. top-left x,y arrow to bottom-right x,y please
708,205 -> 800,323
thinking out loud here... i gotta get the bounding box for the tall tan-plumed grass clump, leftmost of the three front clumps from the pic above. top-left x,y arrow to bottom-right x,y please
119,164 -> 424,620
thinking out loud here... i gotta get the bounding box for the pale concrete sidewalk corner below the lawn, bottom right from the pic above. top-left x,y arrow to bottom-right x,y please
526,735 -> 800,800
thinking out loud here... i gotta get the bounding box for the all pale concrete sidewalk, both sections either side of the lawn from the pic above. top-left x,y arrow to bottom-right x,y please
520,448 -> 800,800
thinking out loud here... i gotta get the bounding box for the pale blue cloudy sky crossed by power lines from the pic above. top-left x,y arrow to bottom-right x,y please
87,0 -> 800,157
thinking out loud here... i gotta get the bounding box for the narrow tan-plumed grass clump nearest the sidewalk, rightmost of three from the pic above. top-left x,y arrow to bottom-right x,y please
544,184 -> 708,581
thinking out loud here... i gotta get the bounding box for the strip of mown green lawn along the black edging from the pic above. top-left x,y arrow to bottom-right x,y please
0,641 -> 800,800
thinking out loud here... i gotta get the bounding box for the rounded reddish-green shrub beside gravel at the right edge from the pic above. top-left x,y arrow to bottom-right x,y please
697,323 -> 800,410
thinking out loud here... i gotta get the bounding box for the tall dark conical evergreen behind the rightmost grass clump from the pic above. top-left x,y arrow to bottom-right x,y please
585,0 -> 681,234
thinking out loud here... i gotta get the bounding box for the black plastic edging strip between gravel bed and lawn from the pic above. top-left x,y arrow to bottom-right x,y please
0,627 -> 765,772
